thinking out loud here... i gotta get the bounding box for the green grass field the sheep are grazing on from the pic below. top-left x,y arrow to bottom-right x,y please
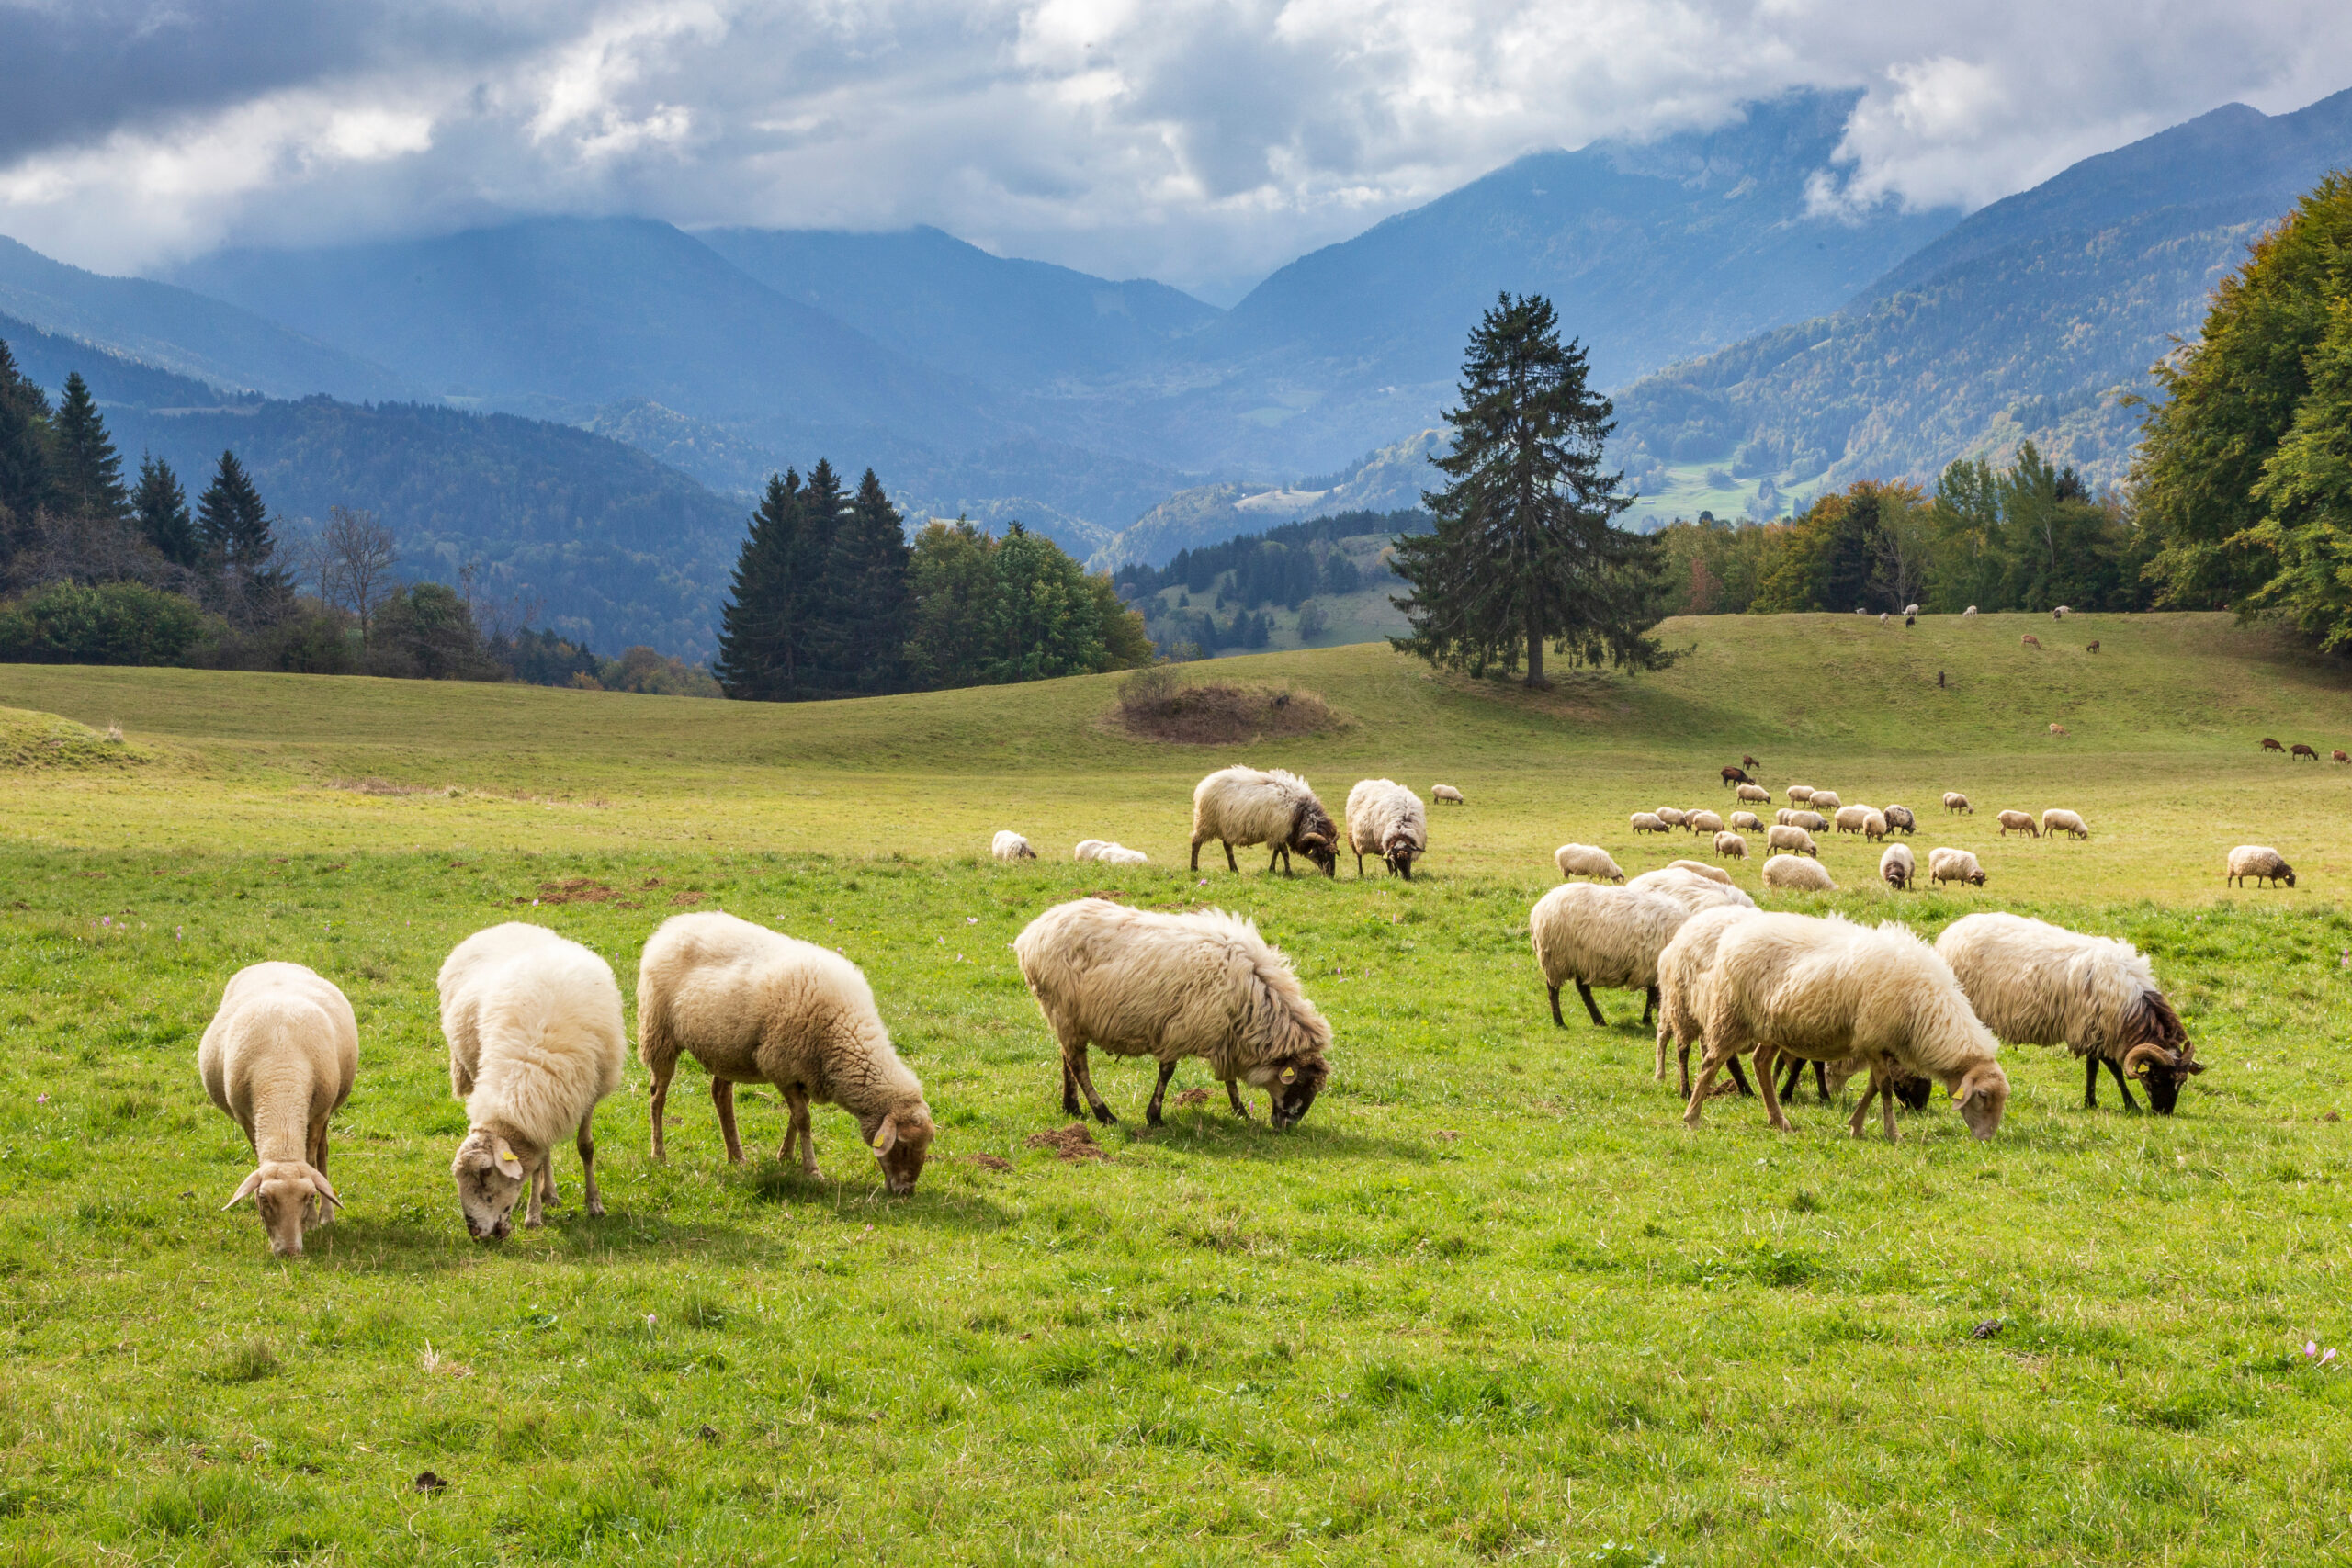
0,616 -> 2352,1565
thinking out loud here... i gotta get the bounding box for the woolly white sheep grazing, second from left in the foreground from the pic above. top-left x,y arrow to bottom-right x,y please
440,921 -> 628,1241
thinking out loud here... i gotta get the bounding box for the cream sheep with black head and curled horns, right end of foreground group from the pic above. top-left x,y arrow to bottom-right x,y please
1936,915 -> 2204,1117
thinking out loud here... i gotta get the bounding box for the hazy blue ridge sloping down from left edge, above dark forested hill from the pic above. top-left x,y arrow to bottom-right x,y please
0,237 -> 416,398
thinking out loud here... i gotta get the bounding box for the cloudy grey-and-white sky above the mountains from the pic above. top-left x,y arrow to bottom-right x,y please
0,0 -> 2352,303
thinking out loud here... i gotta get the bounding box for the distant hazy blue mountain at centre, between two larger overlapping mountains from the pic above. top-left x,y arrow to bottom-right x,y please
696,228 -> 1223,392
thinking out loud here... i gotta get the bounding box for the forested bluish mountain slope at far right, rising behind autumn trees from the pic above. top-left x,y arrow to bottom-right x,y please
1618,92 -> 2352,495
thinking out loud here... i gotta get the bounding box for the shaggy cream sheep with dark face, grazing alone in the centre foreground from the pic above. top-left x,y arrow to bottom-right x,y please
1013,884 -> 1336,1131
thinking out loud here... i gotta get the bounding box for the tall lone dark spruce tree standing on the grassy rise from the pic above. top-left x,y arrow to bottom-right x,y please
1393,294 -> 1668,686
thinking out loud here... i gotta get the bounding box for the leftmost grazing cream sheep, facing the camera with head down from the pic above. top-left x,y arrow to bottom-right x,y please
195,964 -> 360,1258
